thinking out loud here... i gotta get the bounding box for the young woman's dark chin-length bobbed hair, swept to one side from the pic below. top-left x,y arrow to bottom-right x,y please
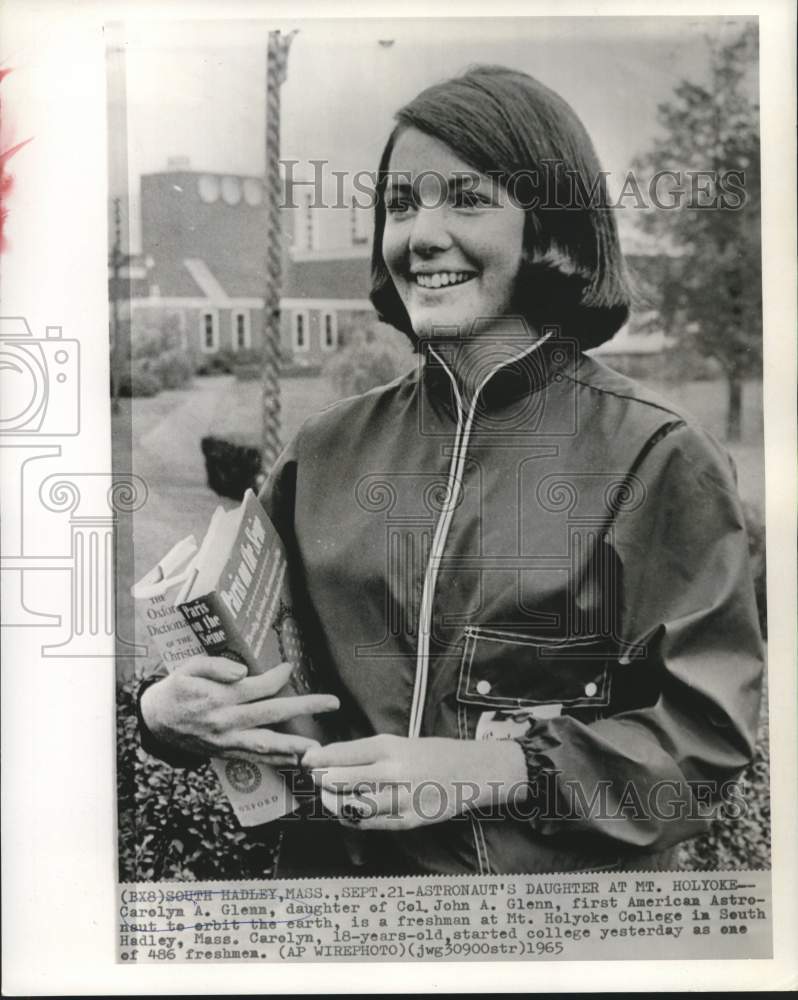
371,66 -> 631,350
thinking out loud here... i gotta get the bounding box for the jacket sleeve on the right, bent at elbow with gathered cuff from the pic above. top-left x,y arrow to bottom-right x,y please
520,424 -> 763,851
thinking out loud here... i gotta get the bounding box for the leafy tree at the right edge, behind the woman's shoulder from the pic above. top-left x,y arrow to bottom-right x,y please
636,25 -> 762,441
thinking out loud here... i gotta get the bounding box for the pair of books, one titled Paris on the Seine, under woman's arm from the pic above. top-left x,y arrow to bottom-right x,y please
133,490 -> 324,826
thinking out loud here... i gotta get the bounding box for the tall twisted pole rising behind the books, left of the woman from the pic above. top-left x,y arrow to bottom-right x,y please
261,31 -> 296,472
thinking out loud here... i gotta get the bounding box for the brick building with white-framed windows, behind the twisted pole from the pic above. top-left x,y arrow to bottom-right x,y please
129,168 -> 396,368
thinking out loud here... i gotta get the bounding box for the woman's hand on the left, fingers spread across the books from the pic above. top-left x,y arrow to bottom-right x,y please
141,656 -> 339,766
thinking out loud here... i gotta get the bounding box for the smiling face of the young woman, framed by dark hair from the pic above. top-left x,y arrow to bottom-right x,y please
382,128 -> 524,337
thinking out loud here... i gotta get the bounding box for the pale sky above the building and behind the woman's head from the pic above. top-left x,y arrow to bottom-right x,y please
109,17 -> 756,249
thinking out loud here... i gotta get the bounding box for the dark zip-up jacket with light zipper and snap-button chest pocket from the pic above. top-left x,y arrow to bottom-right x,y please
262,341 -> 762,873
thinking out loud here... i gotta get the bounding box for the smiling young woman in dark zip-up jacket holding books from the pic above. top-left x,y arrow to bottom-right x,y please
141,67 -> 762,874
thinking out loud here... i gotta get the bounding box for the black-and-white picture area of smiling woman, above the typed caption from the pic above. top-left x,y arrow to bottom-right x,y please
109,11 -> 769,881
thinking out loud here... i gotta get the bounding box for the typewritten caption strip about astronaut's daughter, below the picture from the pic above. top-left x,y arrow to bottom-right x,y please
118,871 -> 772,963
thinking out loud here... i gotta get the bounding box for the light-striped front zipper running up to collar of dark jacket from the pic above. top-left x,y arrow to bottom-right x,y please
407,331 -> 551,737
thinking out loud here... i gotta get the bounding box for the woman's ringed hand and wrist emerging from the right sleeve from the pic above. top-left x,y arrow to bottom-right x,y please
302,735 -> 527,830
